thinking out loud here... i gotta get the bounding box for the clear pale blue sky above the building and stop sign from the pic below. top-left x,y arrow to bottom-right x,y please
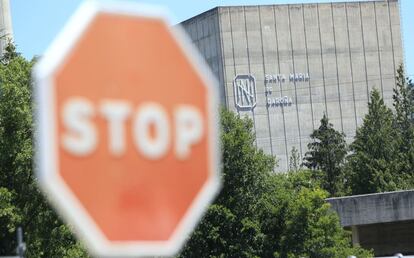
10,0 -> 414,78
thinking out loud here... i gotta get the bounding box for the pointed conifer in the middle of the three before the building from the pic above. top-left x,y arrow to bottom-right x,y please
348,89 -> 402,194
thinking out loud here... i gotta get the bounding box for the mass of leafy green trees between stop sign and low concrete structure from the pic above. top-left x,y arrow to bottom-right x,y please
180,111 -> 372,258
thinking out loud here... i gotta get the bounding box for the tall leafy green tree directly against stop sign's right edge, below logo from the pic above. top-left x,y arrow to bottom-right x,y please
180,110 -> 274,257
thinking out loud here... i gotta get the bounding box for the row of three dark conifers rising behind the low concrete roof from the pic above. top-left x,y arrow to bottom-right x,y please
304,66 -> 414,195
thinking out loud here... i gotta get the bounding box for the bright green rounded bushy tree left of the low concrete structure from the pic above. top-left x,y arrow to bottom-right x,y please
258,170 -> 372,258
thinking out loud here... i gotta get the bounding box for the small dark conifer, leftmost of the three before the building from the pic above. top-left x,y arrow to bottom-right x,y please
304,114 -> 347,195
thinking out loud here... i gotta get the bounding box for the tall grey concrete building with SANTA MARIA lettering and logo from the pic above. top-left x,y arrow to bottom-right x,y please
182,0 -> 403,171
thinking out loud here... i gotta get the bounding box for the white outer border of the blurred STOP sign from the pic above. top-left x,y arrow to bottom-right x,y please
33,1 -> 221,257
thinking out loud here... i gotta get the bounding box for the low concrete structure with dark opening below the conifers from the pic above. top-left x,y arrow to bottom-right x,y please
327,190 -> 414,257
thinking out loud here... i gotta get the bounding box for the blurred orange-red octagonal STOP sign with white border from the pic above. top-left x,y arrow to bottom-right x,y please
34,1 -> 220,256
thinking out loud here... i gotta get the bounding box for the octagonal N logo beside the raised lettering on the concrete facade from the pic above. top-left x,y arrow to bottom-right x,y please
233,74 -> 257,109
